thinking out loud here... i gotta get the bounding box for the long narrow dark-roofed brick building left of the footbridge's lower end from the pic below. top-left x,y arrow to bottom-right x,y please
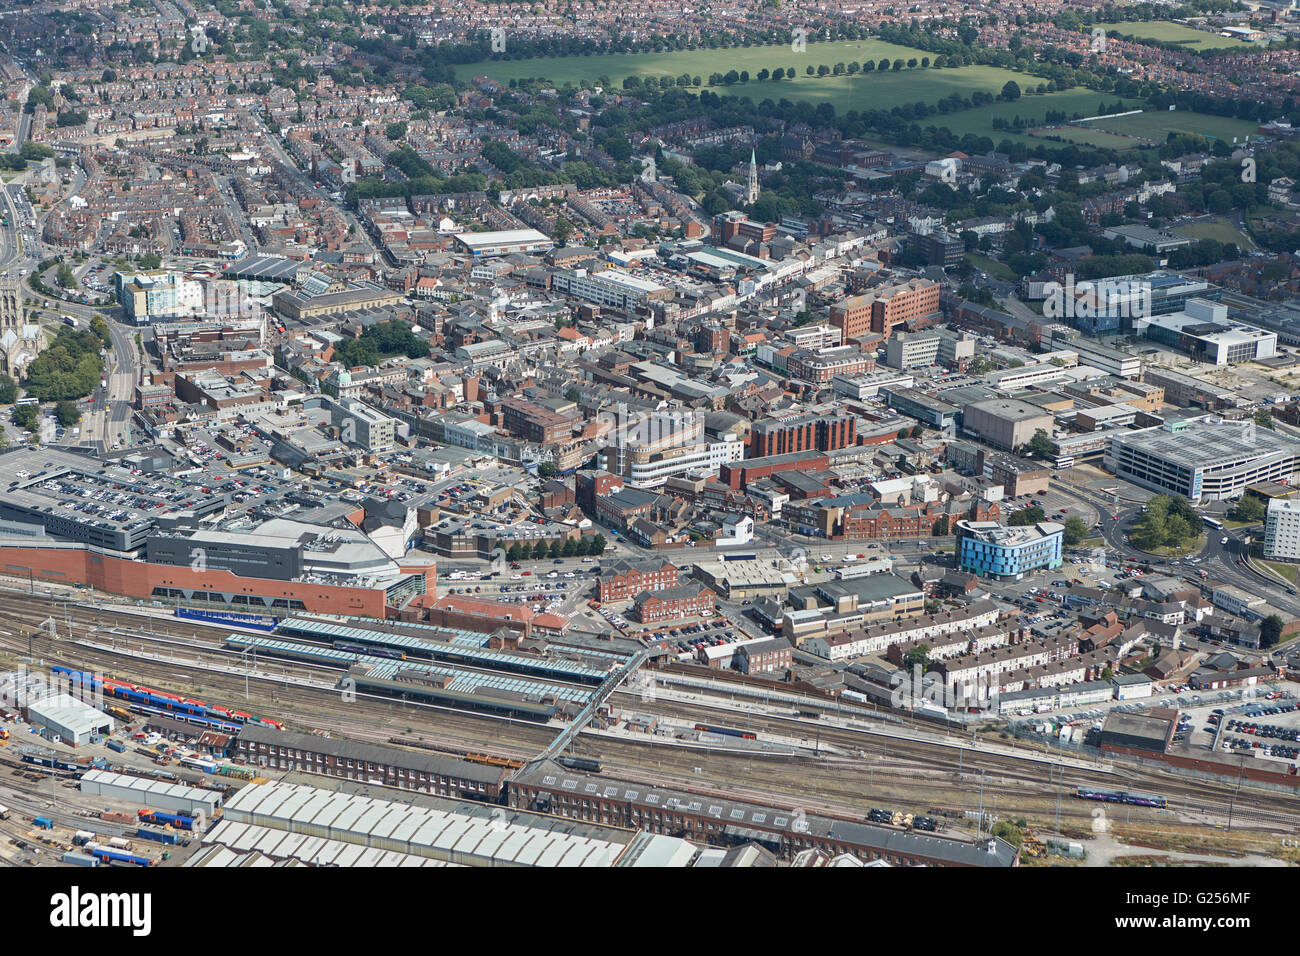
234,724 -> 506,803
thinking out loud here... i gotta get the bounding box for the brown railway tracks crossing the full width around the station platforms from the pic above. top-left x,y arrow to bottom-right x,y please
0,594 -> 1297,830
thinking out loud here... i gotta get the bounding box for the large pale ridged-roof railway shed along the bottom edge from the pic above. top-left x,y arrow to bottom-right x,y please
222,783 -> 698,868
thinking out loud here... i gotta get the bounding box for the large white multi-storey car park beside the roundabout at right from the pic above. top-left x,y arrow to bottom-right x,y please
1105,419 -> 1297,501
